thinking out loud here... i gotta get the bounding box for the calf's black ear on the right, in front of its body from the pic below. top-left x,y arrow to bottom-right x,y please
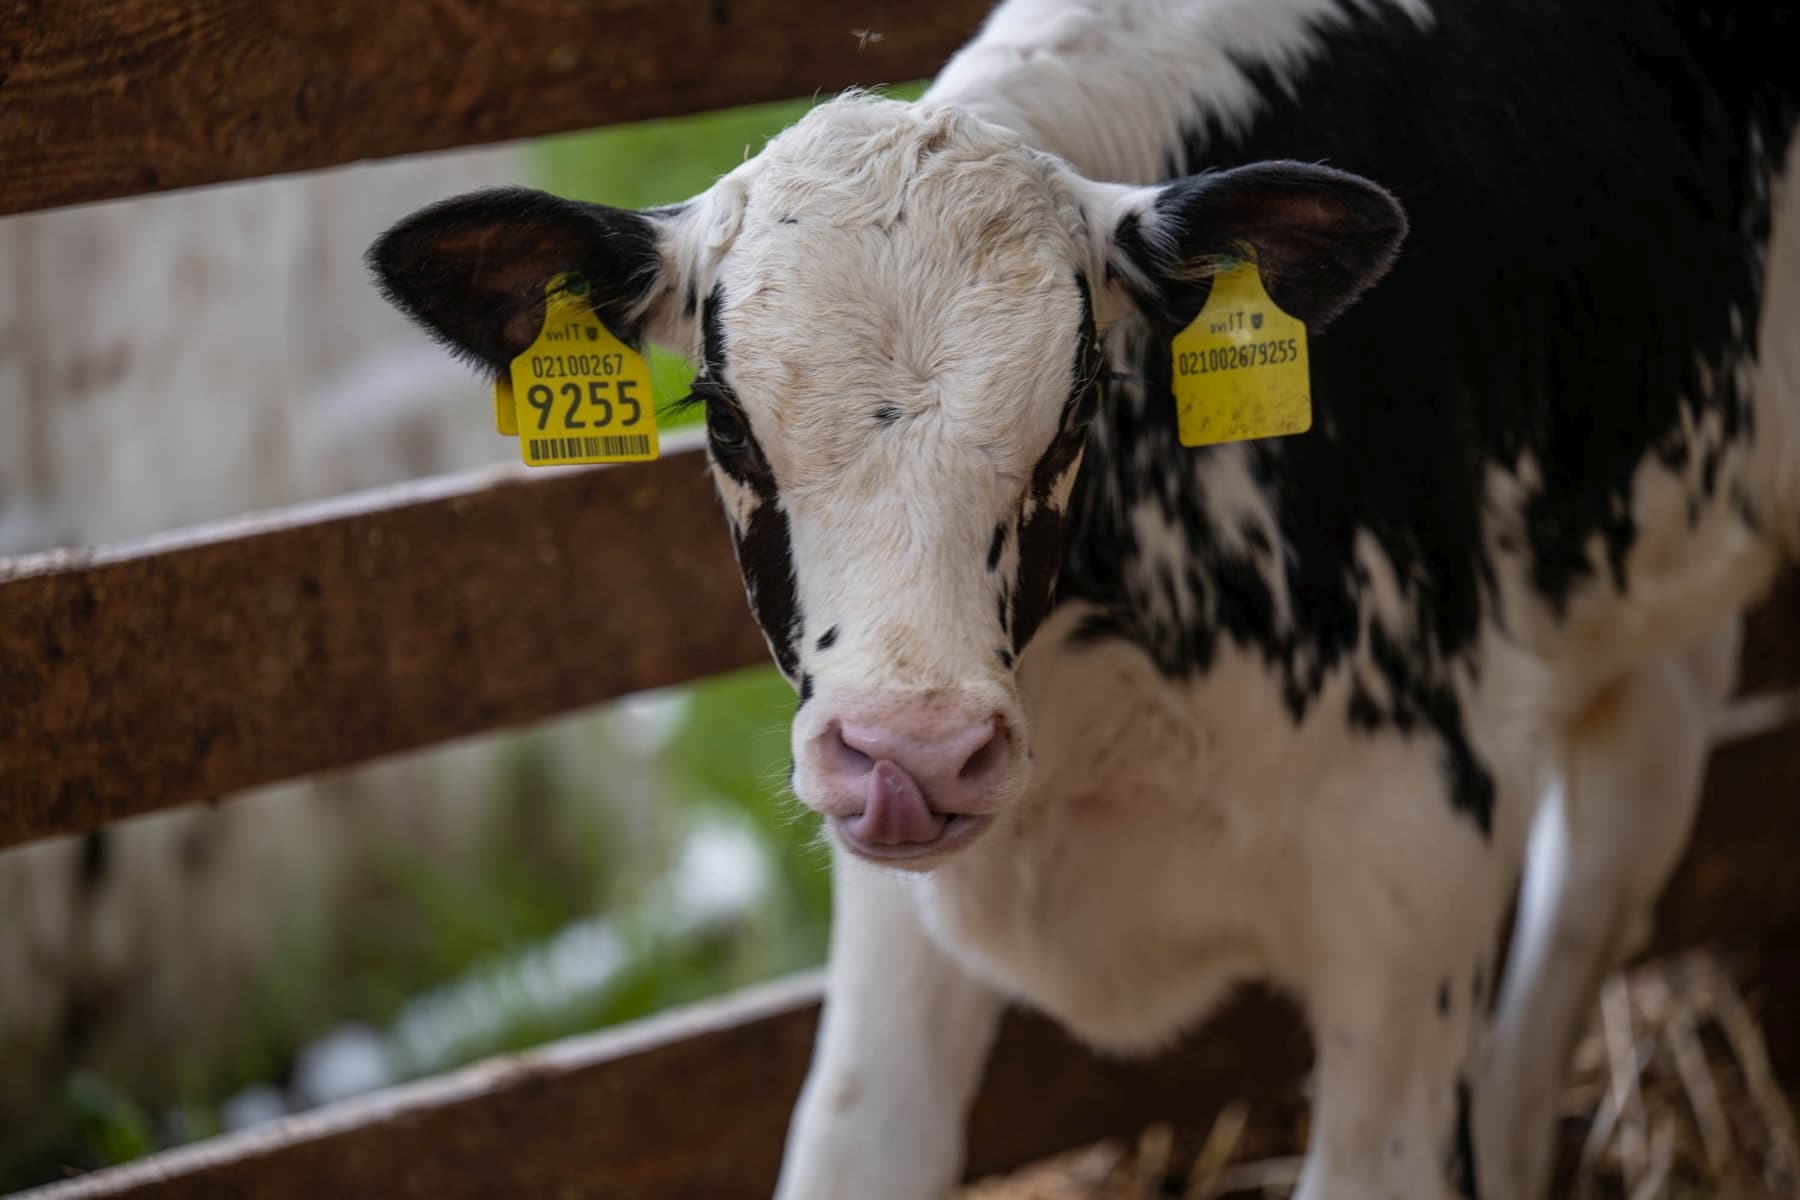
1116,162 -> 1406,333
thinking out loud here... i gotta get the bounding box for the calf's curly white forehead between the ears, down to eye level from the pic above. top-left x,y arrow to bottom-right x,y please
694,97 -> 1087,484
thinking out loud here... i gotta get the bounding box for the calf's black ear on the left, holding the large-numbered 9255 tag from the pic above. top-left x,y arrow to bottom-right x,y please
367,187 -> 662,376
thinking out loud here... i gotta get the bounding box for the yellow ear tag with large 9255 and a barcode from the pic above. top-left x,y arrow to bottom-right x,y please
493,275 -> 659,466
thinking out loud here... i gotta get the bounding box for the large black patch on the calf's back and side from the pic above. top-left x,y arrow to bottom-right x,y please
1058,0 -> 1800,831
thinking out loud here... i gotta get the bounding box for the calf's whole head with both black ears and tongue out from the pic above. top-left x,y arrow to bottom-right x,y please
369,97 -> 1404,865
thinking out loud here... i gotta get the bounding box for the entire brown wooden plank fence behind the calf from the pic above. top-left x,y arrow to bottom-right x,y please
0,0 -> 1800,1200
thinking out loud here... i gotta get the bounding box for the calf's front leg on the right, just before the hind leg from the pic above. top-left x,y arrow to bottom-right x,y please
1296,752 -> 1512,1200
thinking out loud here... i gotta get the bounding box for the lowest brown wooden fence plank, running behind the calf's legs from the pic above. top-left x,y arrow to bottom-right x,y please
25,730 -> 1800,1200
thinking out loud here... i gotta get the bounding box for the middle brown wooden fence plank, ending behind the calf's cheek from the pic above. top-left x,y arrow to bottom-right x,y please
0,431 -> 767,846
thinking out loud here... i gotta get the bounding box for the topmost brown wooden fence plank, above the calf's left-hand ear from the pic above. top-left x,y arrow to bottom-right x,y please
0,0 -> 988,212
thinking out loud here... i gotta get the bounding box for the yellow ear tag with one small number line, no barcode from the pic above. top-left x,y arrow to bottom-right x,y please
1172,257 -> 1312,446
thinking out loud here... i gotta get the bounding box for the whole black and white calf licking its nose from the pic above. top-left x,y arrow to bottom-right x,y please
371,0 -> 1800,1200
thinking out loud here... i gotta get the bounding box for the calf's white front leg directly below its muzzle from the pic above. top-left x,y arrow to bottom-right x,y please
776,853 -> 1001,1200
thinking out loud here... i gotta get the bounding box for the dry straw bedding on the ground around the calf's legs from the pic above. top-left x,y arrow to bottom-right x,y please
961,952 -> 1800,1200
